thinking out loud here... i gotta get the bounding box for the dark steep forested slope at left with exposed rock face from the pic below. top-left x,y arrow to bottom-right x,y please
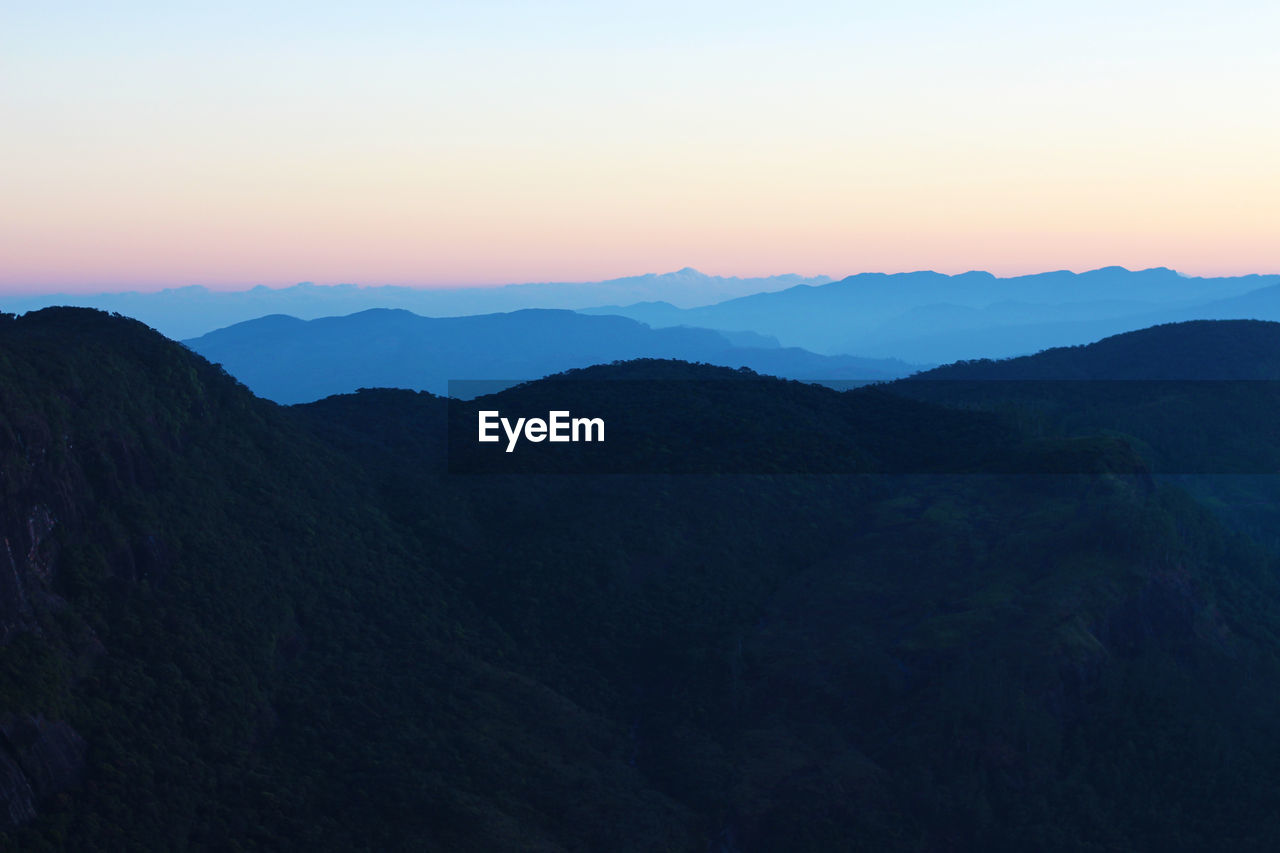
0,310 -> 687,850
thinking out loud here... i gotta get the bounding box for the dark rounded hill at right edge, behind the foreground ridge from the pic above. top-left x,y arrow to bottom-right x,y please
893,320 -> 1280,549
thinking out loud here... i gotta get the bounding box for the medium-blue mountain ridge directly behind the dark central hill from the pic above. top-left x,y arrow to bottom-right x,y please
187,309 -> 914,403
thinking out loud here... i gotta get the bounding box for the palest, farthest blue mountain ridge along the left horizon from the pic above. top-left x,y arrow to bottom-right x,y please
0,266 -> 831,341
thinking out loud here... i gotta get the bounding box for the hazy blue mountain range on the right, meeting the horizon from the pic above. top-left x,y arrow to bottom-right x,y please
588,266 -> 1280,364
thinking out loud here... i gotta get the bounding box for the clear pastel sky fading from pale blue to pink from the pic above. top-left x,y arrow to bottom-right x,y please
0,0 -> 1280,293
